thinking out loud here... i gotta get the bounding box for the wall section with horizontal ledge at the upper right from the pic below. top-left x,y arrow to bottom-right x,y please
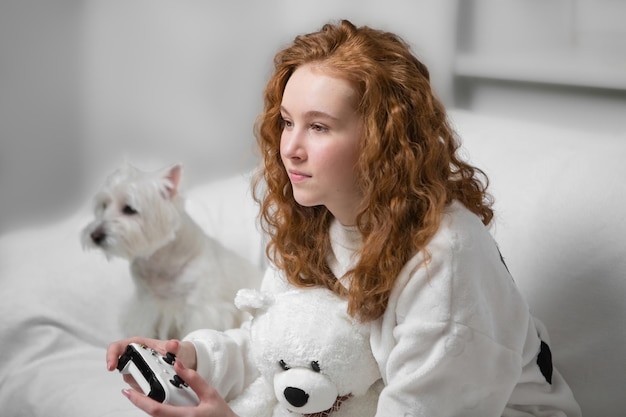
455,0 -> 626,135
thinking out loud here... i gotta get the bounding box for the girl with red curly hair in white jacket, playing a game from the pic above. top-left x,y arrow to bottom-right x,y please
107,21 -> 580,417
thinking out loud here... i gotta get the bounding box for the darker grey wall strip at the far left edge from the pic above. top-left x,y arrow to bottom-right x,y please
0,0 -> 85,232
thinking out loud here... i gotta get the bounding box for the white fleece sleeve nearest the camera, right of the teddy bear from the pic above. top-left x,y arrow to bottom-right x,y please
372,206 -> 532,417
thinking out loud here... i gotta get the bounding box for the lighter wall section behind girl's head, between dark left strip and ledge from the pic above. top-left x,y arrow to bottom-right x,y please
80,0 -> 454,184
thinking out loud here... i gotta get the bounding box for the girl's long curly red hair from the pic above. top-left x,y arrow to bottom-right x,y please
254,20 -> 493,321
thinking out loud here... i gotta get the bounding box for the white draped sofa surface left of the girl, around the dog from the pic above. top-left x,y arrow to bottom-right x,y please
0,175 -> 263,417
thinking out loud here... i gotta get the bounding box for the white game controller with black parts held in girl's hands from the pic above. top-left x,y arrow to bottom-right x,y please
117,343 -> 200,406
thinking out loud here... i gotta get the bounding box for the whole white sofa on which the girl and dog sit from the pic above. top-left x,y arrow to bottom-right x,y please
0,111 -> 626,417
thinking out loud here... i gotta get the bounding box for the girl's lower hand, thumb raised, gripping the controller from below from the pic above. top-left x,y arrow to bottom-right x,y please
122,360 -> 237,417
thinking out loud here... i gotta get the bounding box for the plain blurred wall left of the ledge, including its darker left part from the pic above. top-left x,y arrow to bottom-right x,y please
0,0 -> 456,232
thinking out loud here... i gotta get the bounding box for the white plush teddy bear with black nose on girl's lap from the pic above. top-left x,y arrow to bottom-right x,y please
230,288 -> 383,417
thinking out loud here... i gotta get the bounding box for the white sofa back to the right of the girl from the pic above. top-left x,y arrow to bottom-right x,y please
451,111 -> 626,416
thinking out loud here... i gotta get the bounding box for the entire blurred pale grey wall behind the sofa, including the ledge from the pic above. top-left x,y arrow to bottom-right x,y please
0,0 -> 626,233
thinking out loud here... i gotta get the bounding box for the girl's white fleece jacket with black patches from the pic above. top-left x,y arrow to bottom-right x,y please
186,202 -> 581,417
